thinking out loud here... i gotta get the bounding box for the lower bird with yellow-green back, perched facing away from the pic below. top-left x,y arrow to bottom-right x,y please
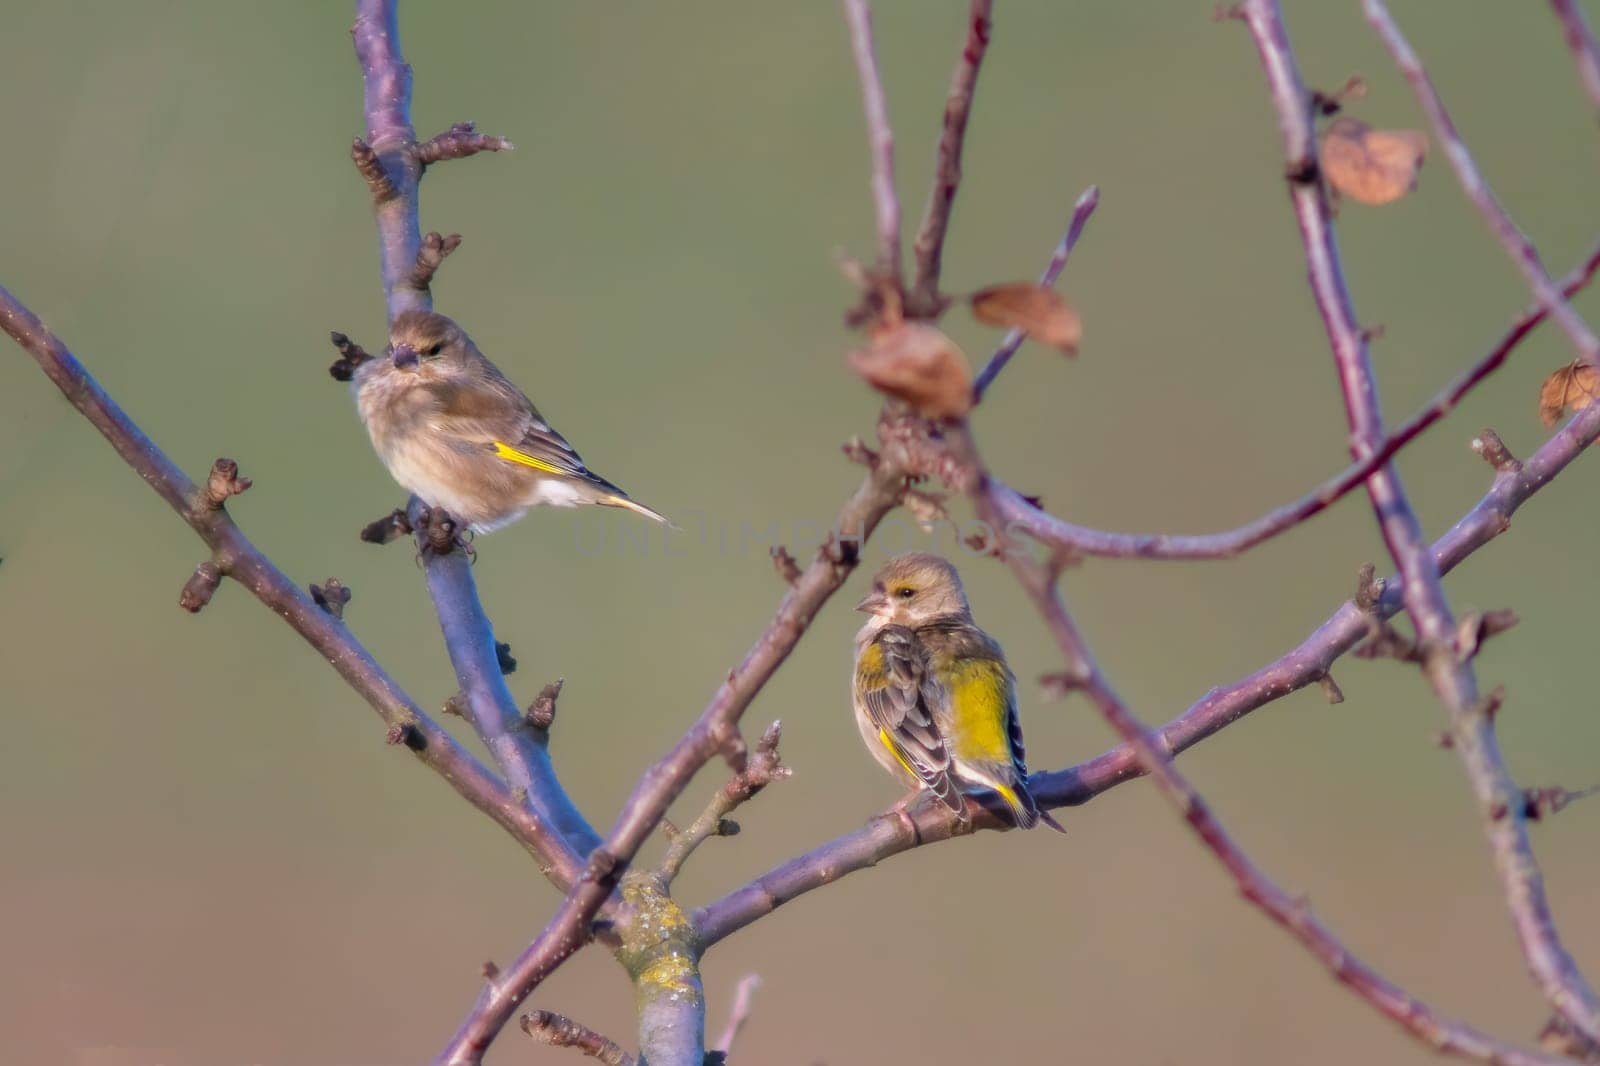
853,552 -> 1066,832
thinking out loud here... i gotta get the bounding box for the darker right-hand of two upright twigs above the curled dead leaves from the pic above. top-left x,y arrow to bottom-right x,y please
906,0 -> 994,319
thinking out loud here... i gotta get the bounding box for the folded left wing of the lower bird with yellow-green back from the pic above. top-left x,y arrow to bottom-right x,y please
856,626 -> 966,815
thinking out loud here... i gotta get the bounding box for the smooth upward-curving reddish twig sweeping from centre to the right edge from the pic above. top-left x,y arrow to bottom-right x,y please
997,236 -> 1600,559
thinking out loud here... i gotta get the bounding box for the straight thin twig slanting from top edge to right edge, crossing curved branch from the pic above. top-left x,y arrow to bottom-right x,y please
1362,0 -> 1600,369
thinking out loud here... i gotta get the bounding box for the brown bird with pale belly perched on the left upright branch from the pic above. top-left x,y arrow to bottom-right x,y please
350,311 -> 672,533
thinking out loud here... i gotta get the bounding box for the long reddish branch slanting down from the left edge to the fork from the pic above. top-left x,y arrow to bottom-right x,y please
0,281 -> 579,884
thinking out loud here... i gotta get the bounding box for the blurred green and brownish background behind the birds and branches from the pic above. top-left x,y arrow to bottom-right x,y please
0,0 -> 1600,1066
